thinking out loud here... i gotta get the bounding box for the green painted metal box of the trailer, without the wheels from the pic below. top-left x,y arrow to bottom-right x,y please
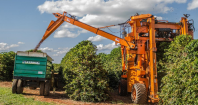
13,55 -> 52,79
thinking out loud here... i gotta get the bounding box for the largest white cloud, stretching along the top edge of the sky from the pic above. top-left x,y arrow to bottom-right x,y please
38,0 -> 187,26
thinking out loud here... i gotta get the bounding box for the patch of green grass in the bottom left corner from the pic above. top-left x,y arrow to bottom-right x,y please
0,87 -> 53,105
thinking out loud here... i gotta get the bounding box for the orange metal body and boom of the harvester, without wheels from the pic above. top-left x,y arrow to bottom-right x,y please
35,12 -> 193,103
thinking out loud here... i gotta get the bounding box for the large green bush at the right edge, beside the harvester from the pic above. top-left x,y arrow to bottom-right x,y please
160,35 -> 198,105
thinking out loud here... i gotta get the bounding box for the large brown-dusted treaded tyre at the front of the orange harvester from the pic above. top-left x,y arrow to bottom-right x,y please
131,83 -> 147,104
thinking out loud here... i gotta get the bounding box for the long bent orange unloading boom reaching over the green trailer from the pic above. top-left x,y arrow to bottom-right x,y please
34,12 -> 135,51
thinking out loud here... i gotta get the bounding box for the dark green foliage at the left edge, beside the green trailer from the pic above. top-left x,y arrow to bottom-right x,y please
0,51 -> 15,81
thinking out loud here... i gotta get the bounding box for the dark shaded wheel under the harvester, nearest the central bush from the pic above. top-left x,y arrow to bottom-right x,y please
118,79 -> 127,96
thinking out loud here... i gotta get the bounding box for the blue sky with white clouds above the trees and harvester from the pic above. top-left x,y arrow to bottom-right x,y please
0,0 -> 198,63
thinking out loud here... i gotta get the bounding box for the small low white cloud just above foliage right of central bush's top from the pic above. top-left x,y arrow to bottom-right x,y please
97,42 -> 118,51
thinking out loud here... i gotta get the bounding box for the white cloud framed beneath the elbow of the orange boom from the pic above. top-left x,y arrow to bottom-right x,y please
54,23 -> 88,38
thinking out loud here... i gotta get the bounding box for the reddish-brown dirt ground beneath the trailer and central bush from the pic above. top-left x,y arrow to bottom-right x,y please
0,82 -> 132,105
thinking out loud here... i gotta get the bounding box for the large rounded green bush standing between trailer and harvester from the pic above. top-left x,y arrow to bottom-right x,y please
61,41 -> 109,102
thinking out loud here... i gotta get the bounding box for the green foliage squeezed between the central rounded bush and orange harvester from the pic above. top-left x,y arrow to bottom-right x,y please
98,47 -> 122,88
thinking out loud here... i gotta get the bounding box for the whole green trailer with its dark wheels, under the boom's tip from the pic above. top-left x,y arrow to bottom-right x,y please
12,51 -> 53,95
